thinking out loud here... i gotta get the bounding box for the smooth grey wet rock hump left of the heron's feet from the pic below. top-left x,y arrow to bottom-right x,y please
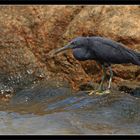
10,81 -> 72,106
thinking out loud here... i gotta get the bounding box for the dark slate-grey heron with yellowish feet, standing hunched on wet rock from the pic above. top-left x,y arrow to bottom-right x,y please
50,36 -> 140,94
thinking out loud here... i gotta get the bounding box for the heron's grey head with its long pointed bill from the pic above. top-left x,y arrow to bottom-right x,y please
53,37 -> 87,55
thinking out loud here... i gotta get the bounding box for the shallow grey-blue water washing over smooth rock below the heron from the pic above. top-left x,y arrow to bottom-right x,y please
0,83 -> 140,135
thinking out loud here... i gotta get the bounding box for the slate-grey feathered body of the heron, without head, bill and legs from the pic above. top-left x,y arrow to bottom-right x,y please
73,37 -> 140,65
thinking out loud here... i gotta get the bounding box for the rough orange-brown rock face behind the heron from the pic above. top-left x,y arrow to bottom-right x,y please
0,5 -> 140,94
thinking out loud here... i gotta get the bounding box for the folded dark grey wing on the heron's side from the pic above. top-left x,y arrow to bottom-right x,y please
91,38 -> 137,64
